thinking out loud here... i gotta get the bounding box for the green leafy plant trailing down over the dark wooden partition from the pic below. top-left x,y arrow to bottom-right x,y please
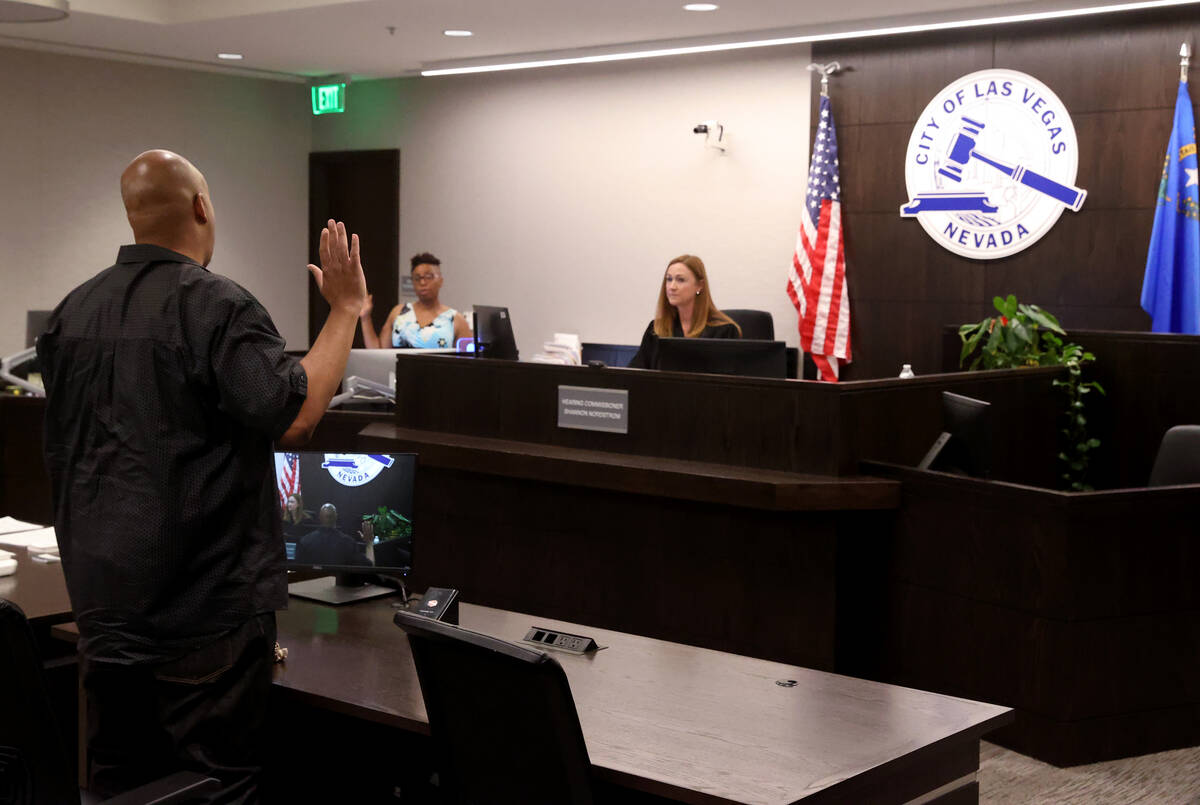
959,294 -> 1104,492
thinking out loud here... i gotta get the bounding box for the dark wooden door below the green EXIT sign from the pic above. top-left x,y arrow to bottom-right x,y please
308,149 -> 400,347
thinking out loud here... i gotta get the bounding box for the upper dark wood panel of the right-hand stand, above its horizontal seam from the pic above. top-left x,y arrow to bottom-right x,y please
890,473 -> 1200,620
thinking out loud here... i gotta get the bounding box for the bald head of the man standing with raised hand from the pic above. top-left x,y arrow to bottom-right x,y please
121,150 -> 215,265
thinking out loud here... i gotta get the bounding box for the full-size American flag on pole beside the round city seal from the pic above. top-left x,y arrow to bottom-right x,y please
787,94 -> 851,383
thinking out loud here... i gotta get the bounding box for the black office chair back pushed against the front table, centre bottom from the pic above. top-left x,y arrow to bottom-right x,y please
395,612 -> 593,805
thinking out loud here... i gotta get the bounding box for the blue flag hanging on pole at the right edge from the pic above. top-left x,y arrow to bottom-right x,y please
1141,82 -> 1200,334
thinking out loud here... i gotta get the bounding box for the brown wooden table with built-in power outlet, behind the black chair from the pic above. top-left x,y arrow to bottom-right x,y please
275,599 -> 1012,805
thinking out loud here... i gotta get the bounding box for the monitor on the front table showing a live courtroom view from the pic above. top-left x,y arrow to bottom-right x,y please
275,452 -> 416,603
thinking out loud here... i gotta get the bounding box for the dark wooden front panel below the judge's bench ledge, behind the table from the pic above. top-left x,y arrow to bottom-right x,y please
398,468 -> 836,669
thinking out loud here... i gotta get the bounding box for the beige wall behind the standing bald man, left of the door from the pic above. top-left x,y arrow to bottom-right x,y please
0,48 -> 312,354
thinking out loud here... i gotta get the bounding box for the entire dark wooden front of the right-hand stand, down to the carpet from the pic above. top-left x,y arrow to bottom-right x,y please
878,468 -> 1200,763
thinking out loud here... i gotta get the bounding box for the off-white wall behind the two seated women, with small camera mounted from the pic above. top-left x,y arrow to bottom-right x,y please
312,46 -> 810,358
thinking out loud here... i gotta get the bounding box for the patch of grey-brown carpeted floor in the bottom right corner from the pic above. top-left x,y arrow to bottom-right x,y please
979,741 -> 1200,805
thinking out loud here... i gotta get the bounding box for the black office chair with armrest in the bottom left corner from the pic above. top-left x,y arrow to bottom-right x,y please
0,599 -> 218,805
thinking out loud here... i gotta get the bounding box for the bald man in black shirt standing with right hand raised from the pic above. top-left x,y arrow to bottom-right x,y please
37,151 -> 366,803
